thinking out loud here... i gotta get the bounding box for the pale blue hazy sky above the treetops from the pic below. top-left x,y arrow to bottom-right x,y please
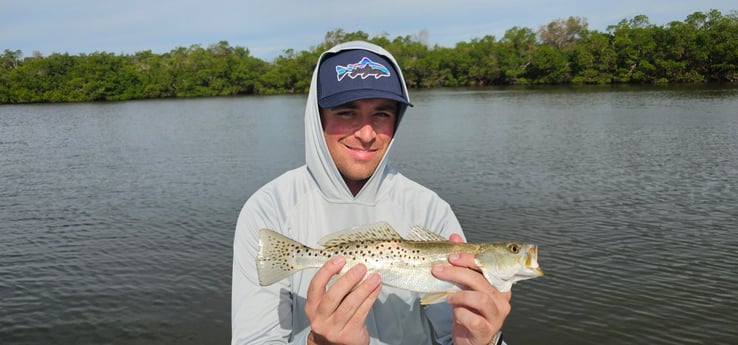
0,0 -> 738,61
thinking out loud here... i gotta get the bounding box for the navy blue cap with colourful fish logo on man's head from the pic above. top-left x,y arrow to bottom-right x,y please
318,49 -> 412,108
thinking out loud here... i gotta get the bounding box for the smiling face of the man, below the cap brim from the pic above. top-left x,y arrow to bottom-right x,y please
320,98 -> 397,195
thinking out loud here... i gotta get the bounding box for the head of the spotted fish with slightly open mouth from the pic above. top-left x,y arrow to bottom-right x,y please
476,242 -> 543,292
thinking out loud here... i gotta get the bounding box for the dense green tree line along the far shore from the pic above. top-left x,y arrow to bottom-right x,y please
0,10 -> 738,104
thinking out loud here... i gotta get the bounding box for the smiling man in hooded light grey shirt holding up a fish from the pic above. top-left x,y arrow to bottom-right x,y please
232,42 -> 510,345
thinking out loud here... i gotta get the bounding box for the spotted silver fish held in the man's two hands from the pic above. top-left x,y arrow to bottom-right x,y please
256,222 -> 543,305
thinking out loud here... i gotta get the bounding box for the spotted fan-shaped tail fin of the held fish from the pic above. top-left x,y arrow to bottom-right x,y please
256,229 -> 308,286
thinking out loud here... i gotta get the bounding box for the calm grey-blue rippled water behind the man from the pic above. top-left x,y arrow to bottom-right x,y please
0,86 -> 738,344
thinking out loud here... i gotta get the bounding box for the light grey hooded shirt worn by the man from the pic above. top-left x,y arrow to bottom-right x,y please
231,42 -> 462,345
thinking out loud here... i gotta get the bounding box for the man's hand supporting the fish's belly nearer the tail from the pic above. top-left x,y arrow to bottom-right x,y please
305,256 -> 382,345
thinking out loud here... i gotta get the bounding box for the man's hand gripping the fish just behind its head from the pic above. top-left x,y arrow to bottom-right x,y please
432,234 -> 512,345
